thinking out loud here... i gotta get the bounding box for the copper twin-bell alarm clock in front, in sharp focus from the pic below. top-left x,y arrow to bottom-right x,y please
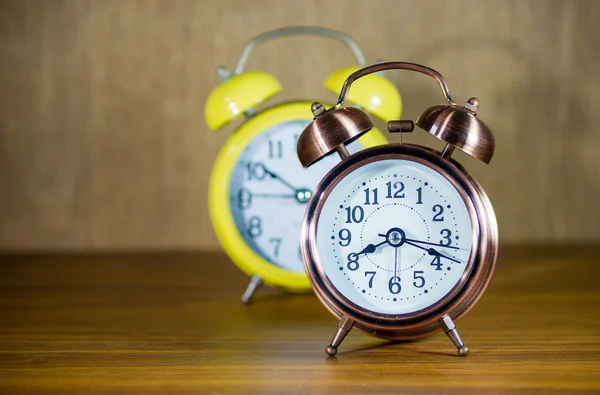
297,62 -> 498,356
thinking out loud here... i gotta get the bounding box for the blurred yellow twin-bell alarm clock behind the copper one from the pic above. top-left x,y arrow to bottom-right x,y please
205,27 -> 401,303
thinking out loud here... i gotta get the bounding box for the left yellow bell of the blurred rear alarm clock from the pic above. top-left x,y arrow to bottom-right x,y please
204,71 -> 281,130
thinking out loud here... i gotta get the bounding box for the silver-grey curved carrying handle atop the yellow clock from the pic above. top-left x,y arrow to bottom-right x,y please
234,26 -> 367,74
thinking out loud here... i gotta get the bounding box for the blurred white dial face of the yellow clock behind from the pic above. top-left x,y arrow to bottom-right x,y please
229,120 -> 361,272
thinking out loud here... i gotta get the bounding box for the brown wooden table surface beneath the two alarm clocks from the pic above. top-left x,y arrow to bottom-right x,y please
0,246 -> 600,394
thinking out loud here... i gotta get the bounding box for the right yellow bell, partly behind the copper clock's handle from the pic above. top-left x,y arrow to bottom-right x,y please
325,66 -> 402,121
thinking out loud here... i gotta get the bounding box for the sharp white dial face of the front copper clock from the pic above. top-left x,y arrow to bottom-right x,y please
316,159 -> 474,315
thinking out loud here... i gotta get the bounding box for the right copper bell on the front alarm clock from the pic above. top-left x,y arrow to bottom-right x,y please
415,97 -> 495,163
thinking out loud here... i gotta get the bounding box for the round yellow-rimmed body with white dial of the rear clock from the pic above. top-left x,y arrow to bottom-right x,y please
209,102 -> 387,291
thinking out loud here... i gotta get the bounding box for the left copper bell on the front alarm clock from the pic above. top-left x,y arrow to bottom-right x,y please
297,103 -> 374,167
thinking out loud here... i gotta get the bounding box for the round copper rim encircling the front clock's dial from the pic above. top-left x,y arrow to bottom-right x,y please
301,144 -> 498,338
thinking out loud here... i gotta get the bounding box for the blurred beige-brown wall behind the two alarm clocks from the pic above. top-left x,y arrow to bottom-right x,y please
0,0 -> 600,250
